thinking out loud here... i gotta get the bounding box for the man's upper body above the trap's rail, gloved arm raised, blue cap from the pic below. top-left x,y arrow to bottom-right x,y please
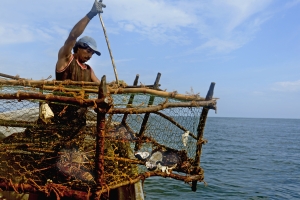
55,0 -> 106,83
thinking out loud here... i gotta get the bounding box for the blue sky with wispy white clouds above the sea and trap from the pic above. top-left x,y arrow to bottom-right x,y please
0,0 -> 300,119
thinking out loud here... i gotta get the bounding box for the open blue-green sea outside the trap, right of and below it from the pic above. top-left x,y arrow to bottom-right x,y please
144,117 -> 300,200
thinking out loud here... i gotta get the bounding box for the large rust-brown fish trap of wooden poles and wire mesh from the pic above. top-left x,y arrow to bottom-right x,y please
0,74 -> 216,199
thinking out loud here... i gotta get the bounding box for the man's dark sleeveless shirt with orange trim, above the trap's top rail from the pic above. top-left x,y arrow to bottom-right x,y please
55,55 -> 92,82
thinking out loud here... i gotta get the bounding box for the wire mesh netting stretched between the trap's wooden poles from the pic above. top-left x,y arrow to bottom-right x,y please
0,83 -> 209,198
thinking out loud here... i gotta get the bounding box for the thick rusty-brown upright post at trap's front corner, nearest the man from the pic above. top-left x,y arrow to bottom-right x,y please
94,76 -> 107,199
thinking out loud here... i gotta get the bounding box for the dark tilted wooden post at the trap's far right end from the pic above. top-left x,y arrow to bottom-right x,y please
192,82 -> 215,191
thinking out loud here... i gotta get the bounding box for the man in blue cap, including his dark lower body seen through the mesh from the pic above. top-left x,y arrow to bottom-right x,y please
45,0 -> 106,136
